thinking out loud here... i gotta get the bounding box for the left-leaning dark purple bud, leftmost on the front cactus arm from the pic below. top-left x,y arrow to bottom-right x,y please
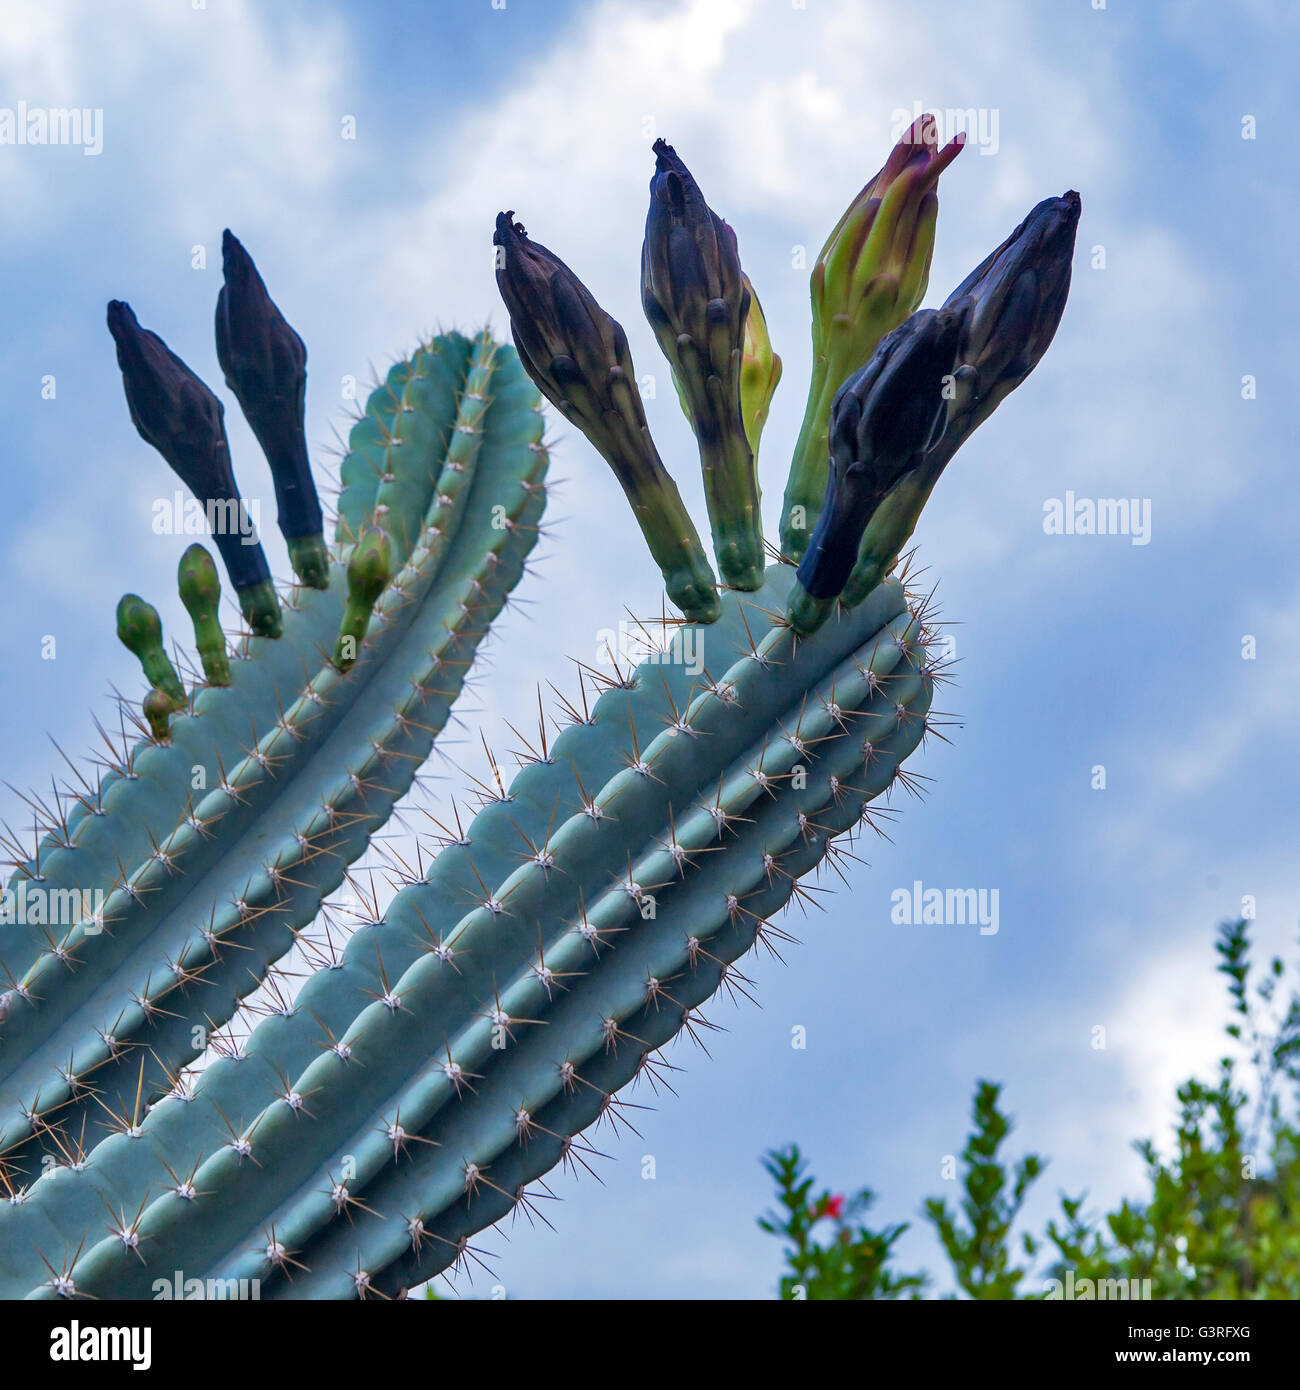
492,213 -> 719,623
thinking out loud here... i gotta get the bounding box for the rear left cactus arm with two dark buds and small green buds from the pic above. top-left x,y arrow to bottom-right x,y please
0,234 -> 546,1173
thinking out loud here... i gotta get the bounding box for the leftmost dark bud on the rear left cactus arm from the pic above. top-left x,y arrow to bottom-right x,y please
108,299 -> 281,637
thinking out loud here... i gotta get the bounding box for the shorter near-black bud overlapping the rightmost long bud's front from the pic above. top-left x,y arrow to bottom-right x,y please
798,309 -> 962,611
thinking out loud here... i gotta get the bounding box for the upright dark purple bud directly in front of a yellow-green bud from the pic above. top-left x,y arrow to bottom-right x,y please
641,140 -> 763,589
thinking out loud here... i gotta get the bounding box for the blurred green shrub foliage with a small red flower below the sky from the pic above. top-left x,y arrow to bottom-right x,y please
759,922 -> 1300,1300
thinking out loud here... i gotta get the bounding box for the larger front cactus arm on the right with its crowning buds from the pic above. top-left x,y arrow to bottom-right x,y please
0,122 -> 1078,1298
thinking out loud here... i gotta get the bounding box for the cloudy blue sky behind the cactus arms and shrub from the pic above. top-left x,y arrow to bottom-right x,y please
0,0 -> 1300,1298
